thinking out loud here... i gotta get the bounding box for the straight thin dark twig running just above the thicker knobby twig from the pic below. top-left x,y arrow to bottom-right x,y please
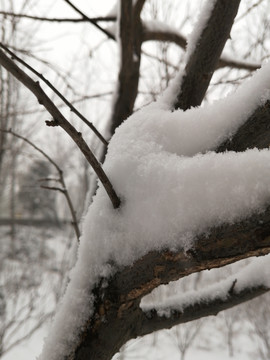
0,42 -> 108,146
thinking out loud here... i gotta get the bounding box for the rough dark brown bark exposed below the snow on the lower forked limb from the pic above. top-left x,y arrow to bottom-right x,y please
74,208 -> 270,360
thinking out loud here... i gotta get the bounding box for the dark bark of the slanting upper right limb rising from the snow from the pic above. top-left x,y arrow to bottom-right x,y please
173,0 -> 240,110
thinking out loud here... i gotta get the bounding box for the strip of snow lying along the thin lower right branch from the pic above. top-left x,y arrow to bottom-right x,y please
141,255 -> 270,317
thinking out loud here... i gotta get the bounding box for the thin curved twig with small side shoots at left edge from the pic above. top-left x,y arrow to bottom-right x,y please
0,129 -> 80,241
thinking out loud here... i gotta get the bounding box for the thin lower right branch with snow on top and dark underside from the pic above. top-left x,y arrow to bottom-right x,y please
137,255 -> 270,336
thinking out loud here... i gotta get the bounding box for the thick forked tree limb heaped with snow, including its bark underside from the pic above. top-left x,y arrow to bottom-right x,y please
39,26 -> 270,359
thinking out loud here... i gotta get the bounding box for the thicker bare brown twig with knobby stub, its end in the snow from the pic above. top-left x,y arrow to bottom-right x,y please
0,50 -> 120,208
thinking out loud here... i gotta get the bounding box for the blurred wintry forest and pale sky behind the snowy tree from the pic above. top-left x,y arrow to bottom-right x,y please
0,0 -> 270,360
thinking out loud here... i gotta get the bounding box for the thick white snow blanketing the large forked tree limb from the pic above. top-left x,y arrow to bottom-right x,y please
40,28 -> 270,360
